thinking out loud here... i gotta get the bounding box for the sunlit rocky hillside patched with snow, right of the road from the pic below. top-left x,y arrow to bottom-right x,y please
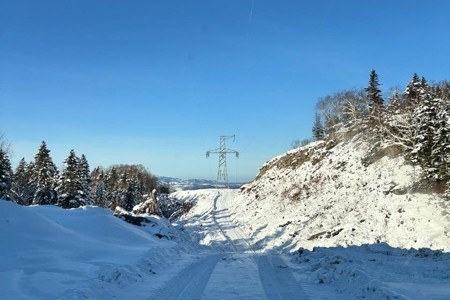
234,134 -> 450,251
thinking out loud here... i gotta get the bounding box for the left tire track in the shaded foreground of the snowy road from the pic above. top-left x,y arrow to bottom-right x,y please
148,254 -> 223,300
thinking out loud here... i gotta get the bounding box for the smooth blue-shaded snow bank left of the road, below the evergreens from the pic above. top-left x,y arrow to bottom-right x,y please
0,200 -> 175,299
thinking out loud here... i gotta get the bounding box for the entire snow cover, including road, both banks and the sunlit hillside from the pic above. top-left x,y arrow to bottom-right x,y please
0,137 -> 450,299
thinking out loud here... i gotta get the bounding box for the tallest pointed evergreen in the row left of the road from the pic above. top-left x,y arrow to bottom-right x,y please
33,142 -> 58,204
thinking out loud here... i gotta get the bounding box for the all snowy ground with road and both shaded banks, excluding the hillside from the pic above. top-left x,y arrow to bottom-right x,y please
0,185 -> 450,299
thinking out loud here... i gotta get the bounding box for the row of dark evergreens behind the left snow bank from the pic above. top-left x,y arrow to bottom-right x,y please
0,142 -> 158,211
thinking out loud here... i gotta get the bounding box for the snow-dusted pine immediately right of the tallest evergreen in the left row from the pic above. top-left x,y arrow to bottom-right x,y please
57,150 -> 86,208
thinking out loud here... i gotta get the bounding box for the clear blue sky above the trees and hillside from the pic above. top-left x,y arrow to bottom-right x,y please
0,0 -> 450,181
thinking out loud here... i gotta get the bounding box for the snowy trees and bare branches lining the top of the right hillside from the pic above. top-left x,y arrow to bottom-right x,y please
306,70 -> 450,199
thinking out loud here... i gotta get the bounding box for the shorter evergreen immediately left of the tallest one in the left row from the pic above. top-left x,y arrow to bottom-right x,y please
11,158 -> 35,205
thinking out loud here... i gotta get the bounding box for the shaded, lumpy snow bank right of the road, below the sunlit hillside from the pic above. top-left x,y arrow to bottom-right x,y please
292,243 -> 450,299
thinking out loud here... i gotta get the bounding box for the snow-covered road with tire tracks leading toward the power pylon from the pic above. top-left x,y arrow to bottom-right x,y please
150,190 -> 309,299
